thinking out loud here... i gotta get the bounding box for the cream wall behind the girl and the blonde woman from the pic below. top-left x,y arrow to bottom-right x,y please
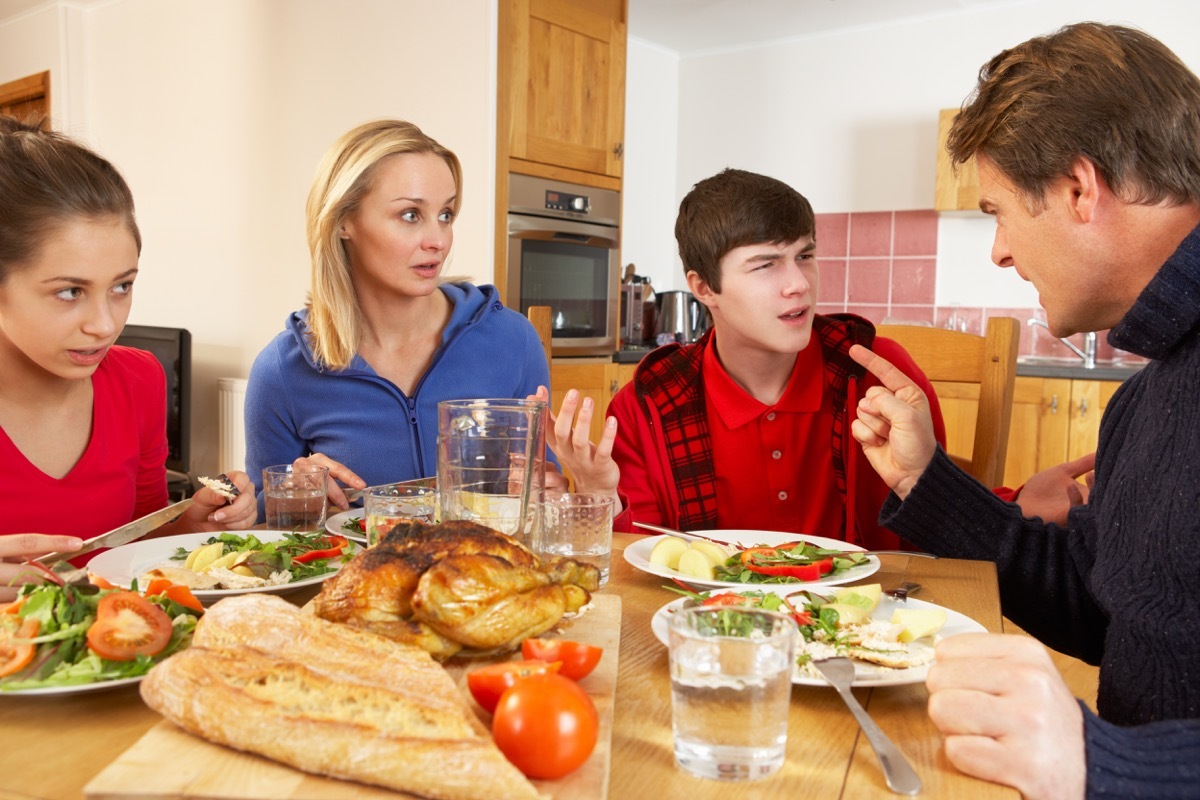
0,0 -> 496,474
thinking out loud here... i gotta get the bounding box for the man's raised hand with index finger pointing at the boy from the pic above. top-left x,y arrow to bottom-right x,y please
850,344 -> 937,500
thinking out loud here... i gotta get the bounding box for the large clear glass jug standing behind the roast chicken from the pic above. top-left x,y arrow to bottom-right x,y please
438,398 -> 546,540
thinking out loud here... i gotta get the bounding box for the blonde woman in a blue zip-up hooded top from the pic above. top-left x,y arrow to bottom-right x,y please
246,120 -> 550,507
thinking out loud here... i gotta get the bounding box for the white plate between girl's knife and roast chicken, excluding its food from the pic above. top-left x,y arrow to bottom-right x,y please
88,530 -> 354,604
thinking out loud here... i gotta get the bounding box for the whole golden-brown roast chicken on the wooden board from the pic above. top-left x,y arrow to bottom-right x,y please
313,521 -> 600,660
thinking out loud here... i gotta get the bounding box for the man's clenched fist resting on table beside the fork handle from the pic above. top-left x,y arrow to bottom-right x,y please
925,633 -> 1087,800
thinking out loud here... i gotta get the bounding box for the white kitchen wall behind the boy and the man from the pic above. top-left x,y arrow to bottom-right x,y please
623,0 -> 1200,307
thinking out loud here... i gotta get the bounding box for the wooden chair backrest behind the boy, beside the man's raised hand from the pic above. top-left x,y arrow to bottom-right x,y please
875,317 -> 1021,488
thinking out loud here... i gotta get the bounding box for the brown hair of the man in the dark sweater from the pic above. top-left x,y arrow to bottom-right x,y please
947,23 -> 1200,207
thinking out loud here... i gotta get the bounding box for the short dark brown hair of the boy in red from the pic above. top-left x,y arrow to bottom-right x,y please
676,169 -> 816,291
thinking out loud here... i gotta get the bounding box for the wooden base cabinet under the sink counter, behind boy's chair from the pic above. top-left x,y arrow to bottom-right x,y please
934,375 -> 1121,488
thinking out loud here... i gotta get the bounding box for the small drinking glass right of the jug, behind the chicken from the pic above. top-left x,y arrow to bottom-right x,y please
529,492 -> 613,585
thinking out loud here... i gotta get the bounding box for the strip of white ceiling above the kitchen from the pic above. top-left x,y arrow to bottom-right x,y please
629,0 -> 1040,55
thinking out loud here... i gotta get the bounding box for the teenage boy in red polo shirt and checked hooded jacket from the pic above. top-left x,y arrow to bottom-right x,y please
550,169 -> 946,549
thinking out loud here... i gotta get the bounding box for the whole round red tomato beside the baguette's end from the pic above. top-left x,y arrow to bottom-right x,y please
492,674 -> 600,780
